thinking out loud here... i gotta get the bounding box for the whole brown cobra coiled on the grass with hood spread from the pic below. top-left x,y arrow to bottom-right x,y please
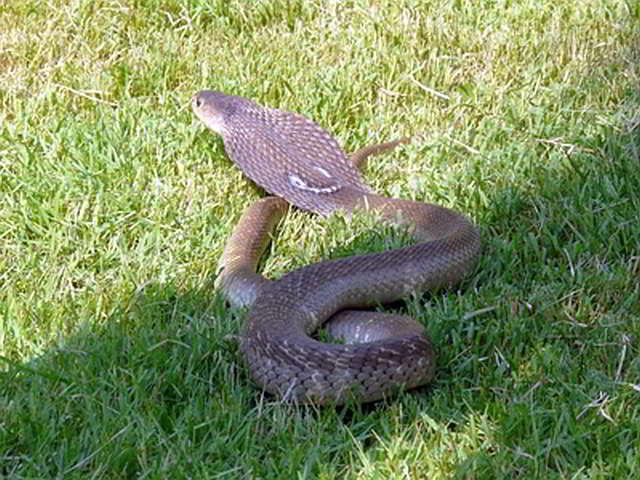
191,90 -> 481,405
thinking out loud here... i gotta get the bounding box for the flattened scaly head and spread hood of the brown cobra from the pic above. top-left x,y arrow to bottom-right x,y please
191,90 -> 370,214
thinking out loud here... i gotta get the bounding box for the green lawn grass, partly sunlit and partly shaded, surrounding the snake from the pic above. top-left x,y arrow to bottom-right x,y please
0,0 -> 640,479
